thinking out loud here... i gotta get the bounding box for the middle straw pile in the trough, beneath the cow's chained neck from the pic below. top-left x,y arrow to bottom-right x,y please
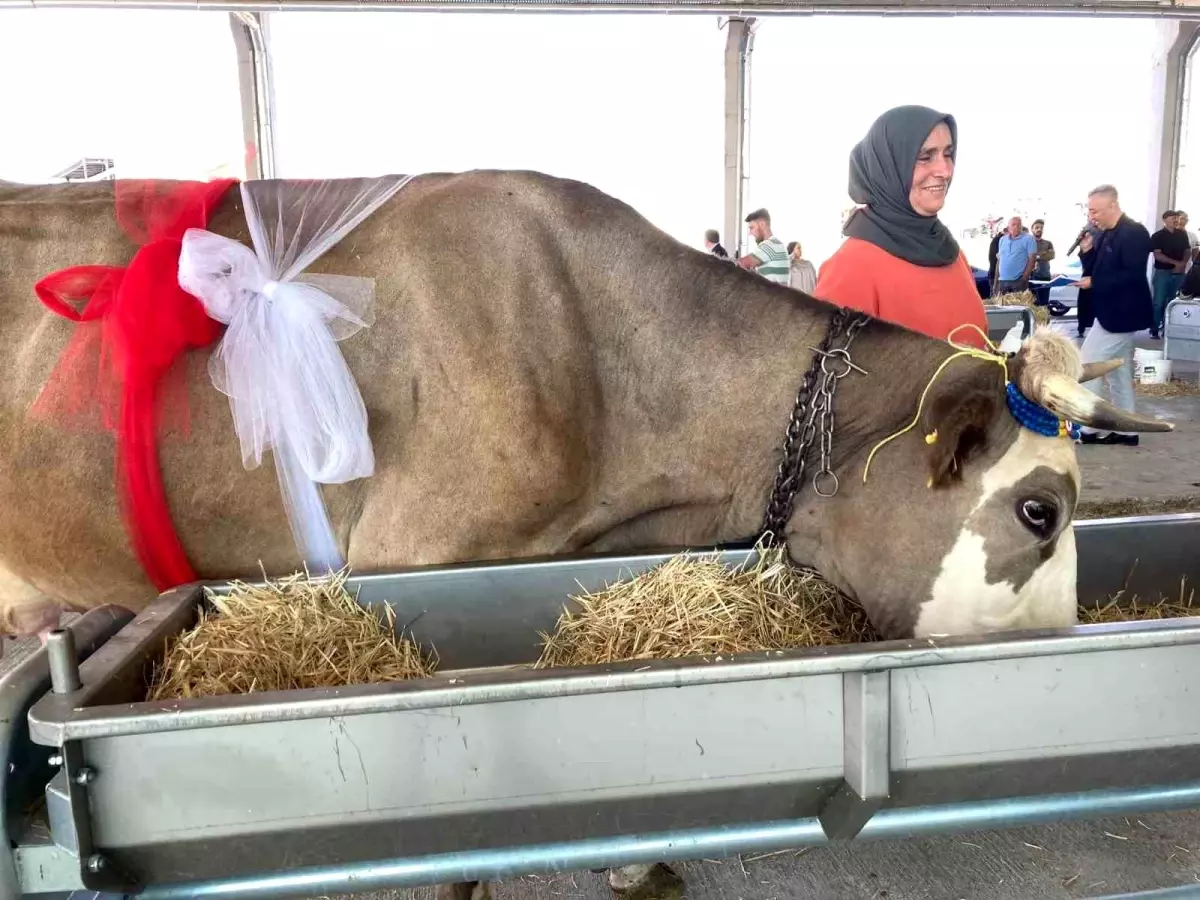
536,550 -> 877,668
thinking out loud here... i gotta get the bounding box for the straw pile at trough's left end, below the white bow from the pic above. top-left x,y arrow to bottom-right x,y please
149,570 -> 437,700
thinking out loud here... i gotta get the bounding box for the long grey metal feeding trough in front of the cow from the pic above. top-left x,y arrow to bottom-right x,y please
0,515 -> 1200,898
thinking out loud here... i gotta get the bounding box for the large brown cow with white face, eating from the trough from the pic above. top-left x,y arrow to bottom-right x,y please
0,172 -> 1169,897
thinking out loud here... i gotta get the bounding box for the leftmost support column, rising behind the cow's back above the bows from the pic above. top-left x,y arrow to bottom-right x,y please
229,12 -> 275,179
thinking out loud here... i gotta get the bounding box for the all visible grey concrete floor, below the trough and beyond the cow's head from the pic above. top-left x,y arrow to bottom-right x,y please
9,336 -> 1200,900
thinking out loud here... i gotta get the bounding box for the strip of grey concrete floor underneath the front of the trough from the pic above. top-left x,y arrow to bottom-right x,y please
326,812 -> 1200,900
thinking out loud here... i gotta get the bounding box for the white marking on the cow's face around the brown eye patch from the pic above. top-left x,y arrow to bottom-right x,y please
913,428 -> 1079,637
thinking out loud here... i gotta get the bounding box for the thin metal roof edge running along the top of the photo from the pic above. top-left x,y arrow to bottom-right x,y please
7,0 -> 1200,19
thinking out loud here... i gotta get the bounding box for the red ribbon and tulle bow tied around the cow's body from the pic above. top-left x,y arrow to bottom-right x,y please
31,179 -> 236,590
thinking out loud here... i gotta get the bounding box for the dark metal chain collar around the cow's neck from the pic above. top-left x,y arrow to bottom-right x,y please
762,310 -> 869,545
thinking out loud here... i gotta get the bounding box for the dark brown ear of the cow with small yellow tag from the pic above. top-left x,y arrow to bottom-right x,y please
923,373 -> 1001,487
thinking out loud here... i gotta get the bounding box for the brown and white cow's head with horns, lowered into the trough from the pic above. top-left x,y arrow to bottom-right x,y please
788,329 -> 1172,637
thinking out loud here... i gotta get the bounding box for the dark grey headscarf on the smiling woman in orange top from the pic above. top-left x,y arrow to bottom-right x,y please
842,106 -> 959,266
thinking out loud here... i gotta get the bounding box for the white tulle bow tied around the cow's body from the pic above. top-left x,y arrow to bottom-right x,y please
179,178 -> 408,570
